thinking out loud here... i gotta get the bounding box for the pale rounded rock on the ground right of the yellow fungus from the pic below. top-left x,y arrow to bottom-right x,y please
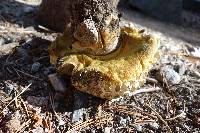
156,66 -> 181,85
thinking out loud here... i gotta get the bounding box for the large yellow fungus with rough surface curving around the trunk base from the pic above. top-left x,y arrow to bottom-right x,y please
49,28 -> 159,99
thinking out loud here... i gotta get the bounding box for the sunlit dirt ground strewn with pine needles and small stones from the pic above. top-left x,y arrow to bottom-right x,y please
0,0 -> 200,133
